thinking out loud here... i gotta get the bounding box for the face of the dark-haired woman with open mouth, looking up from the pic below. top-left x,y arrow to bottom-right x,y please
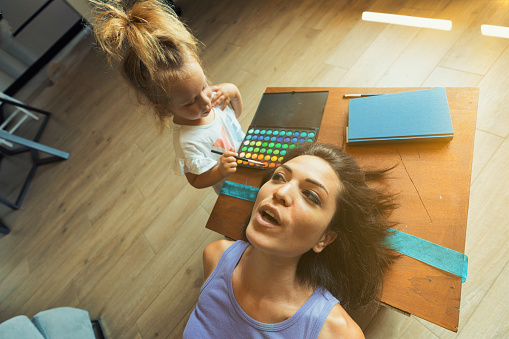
246,155 -> 341,257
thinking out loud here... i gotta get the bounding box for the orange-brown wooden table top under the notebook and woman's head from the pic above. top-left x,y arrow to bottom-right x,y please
206,87 -> 479,332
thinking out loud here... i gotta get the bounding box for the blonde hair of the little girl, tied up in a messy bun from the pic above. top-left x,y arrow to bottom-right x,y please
91,0 -> 200,125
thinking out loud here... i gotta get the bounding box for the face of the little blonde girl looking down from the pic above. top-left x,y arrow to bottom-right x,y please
171,62 -> 212,125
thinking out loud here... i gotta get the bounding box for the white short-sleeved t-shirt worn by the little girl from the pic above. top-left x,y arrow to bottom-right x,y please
173,106 -> 245,192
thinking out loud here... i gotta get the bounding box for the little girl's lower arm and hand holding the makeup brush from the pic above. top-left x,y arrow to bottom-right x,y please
186,148 -> 237,188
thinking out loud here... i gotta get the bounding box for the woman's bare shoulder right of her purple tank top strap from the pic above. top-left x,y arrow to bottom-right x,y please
318,304 -> 364,339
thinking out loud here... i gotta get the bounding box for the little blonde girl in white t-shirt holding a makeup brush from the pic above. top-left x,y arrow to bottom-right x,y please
91,0 -> 244,192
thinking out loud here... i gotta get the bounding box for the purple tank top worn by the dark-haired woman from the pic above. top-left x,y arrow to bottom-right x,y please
184,240 -> 338,339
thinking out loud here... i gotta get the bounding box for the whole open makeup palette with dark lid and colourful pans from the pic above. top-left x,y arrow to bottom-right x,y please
237,91 -> 329,169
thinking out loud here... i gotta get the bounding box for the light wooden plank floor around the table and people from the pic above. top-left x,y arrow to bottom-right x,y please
0,0 -> 509,338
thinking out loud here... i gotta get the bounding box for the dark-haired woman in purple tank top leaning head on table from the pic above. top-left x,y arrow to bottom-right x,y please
184,144 -> 395,338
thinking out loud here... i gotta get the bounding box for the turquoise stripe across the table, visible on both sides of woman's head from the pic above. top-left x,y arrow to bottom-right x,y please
221,181 -> 468,282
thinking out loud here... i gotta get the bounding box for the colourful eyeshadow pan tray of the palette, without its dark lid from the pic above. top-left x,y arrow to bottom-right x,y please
237,126 -> 318,168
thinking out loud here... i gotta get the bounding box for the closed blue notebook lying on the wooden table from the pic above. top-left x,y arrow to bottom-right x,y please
346,88 -> 454,144
